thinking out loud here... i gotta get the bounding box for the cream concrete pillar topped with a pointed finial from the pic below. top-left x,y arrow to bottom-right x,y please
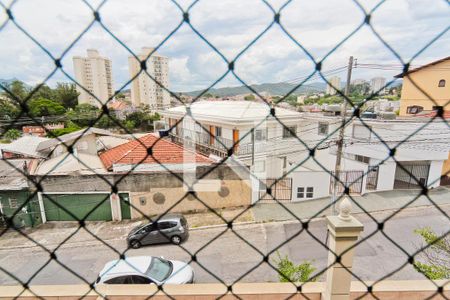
322,197 -> 364,300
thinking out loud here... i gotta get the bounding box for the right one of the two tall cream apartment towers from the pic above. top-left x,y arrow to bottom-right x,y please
128,47 -> 170,109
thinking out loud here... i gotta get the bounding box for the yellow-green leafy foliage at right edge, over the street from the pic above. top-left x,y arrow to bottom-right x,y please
414,227 -> 450,280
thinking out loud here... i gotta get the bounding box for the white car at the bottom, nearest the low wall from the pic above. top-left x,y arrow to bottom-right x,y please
95,256 -> 194,285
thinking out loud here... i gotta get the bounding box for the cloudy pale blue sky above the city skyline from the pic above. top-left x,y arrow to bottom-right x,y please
0,0 -> 450,92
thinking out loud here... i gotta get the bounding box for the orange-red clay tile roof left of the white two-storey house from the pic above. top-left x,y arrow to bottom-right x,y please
100,134 -> 213,170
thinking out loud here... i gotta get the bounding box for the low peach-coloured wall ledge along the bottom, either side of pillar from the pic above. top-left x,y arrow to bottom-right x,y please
0,280 -> 450,300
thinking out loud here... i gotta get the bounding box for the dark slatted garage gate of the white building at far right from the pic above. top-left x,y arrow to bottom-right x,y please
394,161 -> 430,189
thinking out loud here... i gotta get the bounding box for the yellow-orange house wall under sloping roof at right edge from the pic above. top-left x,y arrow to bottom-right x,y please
396,56 -> 450,116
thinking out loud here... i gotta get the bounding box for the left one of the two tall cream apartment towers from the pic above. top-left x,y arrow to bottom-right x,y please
73,49 -> 114,107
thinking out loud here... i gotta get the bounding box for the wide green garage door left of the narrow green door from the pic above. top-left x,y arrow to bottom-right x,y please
42,194 -> 112,221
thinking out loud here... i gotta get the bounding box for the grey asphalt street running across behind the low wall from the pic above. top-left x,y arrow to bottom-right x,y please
0,206 -> 450,285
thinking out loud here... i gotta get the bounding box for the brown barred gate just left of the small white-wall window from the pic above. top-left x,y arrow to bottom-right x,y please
259,178 -> 292,203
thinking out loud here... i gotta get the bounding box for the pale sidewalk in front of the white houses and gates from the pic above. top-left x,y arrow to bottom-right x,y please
252,187 -> 450,222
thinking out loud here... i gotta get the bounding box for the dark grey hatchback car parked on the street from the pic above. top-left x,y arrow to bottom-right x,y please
127,214 -> 189,249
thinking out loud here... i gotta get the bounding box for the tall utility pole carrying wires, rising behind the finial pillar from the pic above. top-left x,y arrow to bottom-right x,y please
331,56 -> 353,215
